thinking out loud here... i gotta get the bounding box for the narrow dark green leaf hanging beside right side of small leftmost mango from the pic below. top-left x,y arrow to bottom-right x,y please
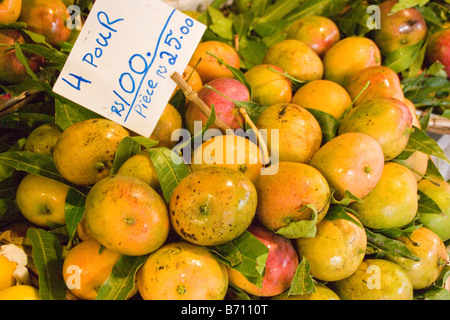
65,188 -> 86,238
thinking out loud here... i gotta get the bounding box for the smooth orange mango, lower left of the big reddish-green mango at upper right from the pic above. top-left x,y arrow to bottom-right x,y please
323,36 -> 381,88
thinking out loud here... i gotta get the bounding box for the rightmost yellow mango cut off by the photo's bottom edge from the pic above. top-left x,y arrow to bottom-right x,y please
333,259 -> 413,300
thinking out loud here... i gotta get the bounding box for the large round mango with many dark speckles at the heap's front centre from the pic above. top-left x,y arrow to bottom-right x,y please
169,167 -> 257,246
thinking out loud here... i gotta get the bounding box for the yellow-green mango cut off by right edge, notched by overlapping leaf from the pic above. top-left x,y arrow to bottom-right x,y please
417,179 -> 450,242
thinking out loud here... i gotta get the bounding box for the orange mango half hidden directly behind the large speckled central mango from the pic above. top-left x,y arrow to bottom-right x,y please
190,134 -> 263,182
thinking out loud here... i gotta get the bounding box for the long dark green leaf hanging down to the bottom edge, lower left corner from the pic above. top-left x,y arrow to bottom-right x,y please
26,228 -> 66,300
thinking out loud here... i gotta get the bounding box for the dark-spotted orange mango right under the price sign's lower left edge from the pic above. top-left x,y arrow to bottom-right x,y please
53,119 -> 129,186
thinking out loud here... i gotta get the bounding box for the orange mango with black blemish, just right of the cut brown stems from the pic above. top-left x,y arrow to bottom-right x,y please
256,103 -> 322,163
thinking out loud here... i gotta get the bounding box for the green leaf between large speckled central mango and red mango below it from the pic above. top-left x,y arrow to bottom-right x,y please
207,231 -> 269,287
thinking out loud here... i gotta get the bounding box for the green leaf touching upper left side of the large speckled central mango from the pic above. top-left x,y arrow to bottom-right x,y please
148,148 -> 190,203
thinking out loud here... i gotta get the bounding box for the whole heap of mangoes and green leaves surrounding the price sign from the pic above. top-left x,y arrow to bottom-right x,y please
0,0 -> 450,301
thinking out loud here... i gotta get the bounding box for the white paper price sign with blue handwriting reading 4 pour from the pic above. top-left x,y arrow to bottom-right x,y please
53,0 -> 206,137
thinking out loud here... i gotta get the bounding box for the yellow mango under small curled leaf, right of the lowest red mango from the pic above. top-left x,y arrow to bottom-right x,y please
295,213 -> 367,281
